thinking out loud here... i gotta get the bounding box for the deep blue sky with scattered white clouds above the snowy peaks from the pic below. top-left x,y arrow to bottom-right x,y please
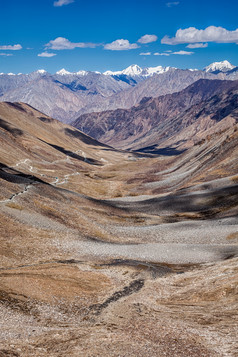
0,0 -> 238,73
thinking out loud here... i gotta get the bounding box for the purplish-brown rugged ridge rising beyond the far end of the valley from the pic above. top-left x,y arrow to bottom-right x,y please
73,80 -> 238,149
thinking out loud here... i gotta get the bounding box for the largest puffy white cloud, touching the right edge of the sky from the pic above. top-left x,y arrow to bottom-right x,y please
161,26 -> 238,45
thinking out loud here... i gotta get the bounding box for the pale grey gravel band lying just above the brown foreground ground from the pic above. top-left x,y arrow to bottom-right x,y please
58,241 -> 238,264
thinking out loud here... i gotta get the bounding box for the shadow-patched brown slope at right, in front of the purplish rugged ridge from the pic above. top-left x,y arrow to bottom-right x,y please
131,82 -> 238,152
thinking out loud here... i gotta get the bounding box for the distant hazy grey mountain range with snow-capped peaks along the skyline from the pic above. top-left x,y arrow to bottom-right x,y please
0,61 -> 238,122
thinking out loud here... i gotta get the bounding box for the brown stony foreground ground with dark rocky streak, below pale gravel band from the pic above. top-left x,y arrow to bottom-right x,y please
0,258 -> 238,356
